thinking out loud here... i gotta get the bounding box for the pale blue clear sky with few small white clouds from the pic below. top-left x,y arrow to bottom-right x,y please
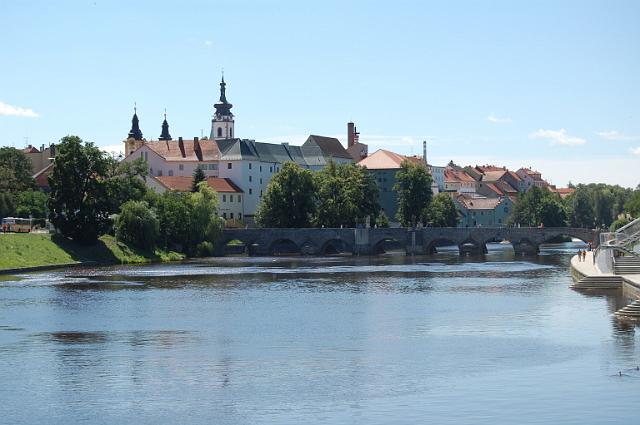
0,0 -> 640,187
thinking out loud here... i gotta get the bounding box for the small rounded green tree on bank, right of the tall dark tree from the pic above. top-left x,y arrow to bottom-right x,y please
114,201 -> 160,250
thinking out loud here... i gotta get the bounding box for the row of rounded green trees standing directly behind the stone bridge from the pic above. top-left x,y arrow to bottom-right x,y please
256,161 -> 458,228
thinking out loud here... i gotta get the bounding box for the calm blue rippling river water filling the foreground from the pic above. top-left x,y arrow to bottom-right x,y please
0,244 -> 640,424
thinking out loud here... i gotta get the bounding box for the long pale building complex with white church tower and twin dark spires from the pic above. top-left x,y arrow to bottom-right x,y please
124,77 -> 358,224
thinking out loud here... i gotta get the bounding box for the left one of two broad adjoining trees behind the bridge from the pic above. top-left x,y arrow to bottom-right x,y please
256,162 -> 316,227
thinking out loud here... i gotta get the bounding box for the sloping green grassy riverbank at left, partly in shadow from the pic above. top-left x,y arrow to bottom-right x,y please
0,233 -> 184,271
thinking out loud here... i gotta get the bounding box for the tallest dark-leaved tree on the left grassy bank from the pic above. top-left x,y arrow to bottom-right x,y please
48,136 -> 109,244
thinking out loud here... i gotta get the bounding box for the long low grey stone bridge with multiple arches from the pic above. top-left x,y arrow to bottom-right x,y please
216,227 -> 600,256
